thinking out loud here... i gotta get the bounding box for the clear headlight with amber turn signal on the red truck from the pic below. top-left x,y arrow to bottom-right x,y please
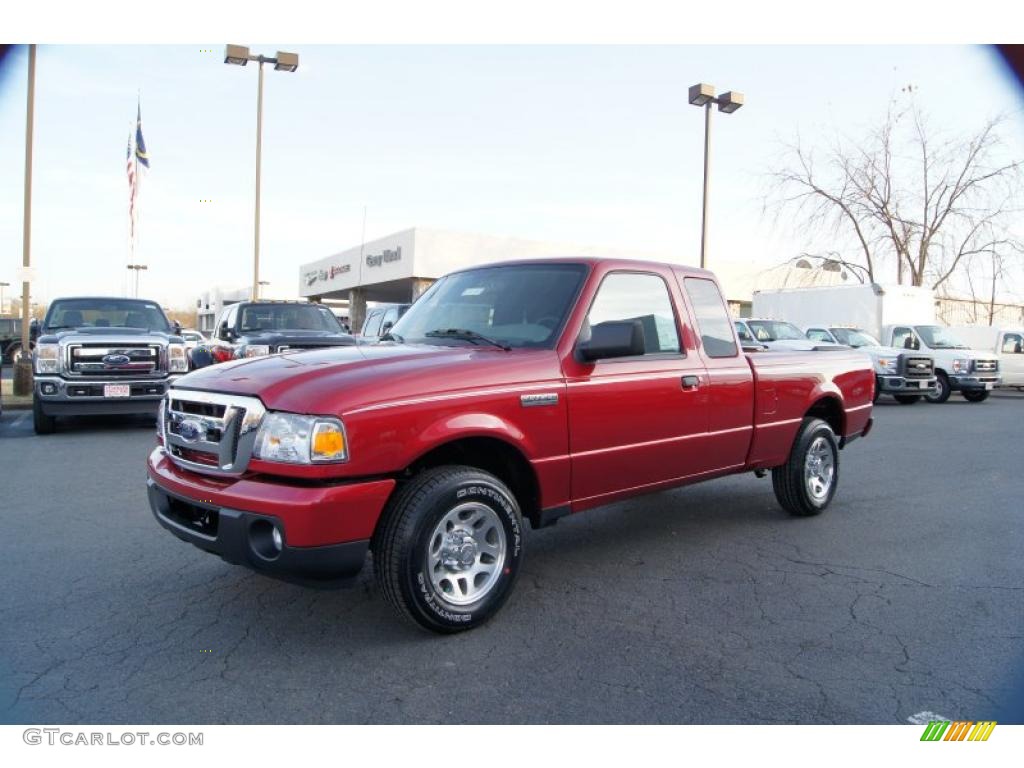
253,413 -> 348,464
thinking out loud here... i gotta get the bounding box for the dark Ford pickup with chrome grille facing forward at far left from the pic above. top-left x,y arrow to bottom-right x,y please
32,297 -> 188,434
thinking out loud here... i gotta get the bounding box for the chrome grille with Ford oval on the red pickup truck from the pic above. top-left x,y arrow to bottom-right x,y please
160,387 -> 266,475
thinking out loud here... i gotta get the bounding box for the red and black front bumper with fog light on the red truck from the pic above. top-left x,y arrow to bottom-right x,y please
147,446 -> 395,583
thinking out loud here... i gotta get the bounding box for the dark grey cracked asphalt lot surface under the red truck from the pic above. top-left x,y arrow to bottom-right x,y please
0,394 -> 1024,724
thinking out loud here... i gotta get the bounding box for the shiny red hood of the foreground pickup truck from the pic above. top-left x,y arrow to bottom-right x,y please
175,343 -> 561,415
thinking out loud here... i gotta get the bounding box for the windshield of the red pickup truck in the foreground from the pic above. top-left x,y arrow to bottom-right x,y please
390,263 -> 586,349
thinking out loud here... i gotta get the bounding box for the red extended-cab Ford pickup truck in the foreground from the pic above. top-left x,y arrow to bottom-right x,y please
148,259 -> 874,632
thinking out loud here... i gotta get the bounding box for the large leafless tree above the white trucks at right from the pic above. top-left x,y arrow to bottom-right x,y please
765,101 -> 1024,289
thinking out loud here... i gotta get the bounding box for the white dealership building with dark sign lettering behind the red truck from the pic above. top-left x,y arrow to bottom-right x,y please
299,227 -> 720,330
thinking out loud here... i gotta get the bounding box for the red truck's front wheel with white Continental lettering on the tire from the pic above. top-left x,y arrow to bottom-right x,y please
372,466 -> 523,634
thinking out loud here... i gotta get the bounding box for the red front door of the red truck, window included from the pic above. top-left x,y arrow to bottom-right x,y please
563,270 -> 708,509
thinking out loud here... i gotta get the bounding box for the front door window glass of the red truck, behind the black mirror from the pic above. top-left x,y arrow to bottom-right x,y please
587,272 -> 680,354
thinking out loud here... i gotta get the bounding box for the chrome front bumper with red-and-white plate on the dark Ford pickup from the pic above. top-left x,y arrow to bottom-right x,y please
33,374 -> 183,416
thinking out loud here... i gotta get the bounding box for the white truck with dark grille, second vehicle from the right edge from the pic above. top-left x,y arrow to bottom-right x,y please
882,324 -> 1001,402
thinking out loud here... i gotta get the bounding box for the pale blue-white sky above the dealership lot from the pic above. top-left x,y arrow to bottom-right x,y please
0,41 -> 1024,307
